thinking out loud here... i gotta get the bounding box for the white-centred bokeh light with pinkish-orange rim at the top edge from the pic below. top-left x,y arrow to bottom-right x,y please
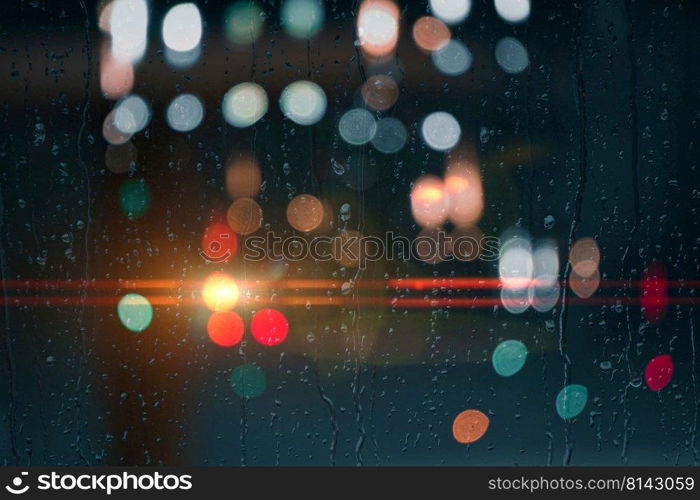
357,0 -> 399,57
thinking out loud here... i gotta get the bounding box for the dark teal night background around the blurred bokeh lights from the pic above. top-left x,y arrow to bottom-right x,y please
0,0 -> 700,466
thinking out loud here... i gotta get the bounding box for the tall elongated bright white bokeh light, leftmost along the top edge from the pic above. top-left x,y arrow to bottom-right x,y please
109,0 -> 148,62
